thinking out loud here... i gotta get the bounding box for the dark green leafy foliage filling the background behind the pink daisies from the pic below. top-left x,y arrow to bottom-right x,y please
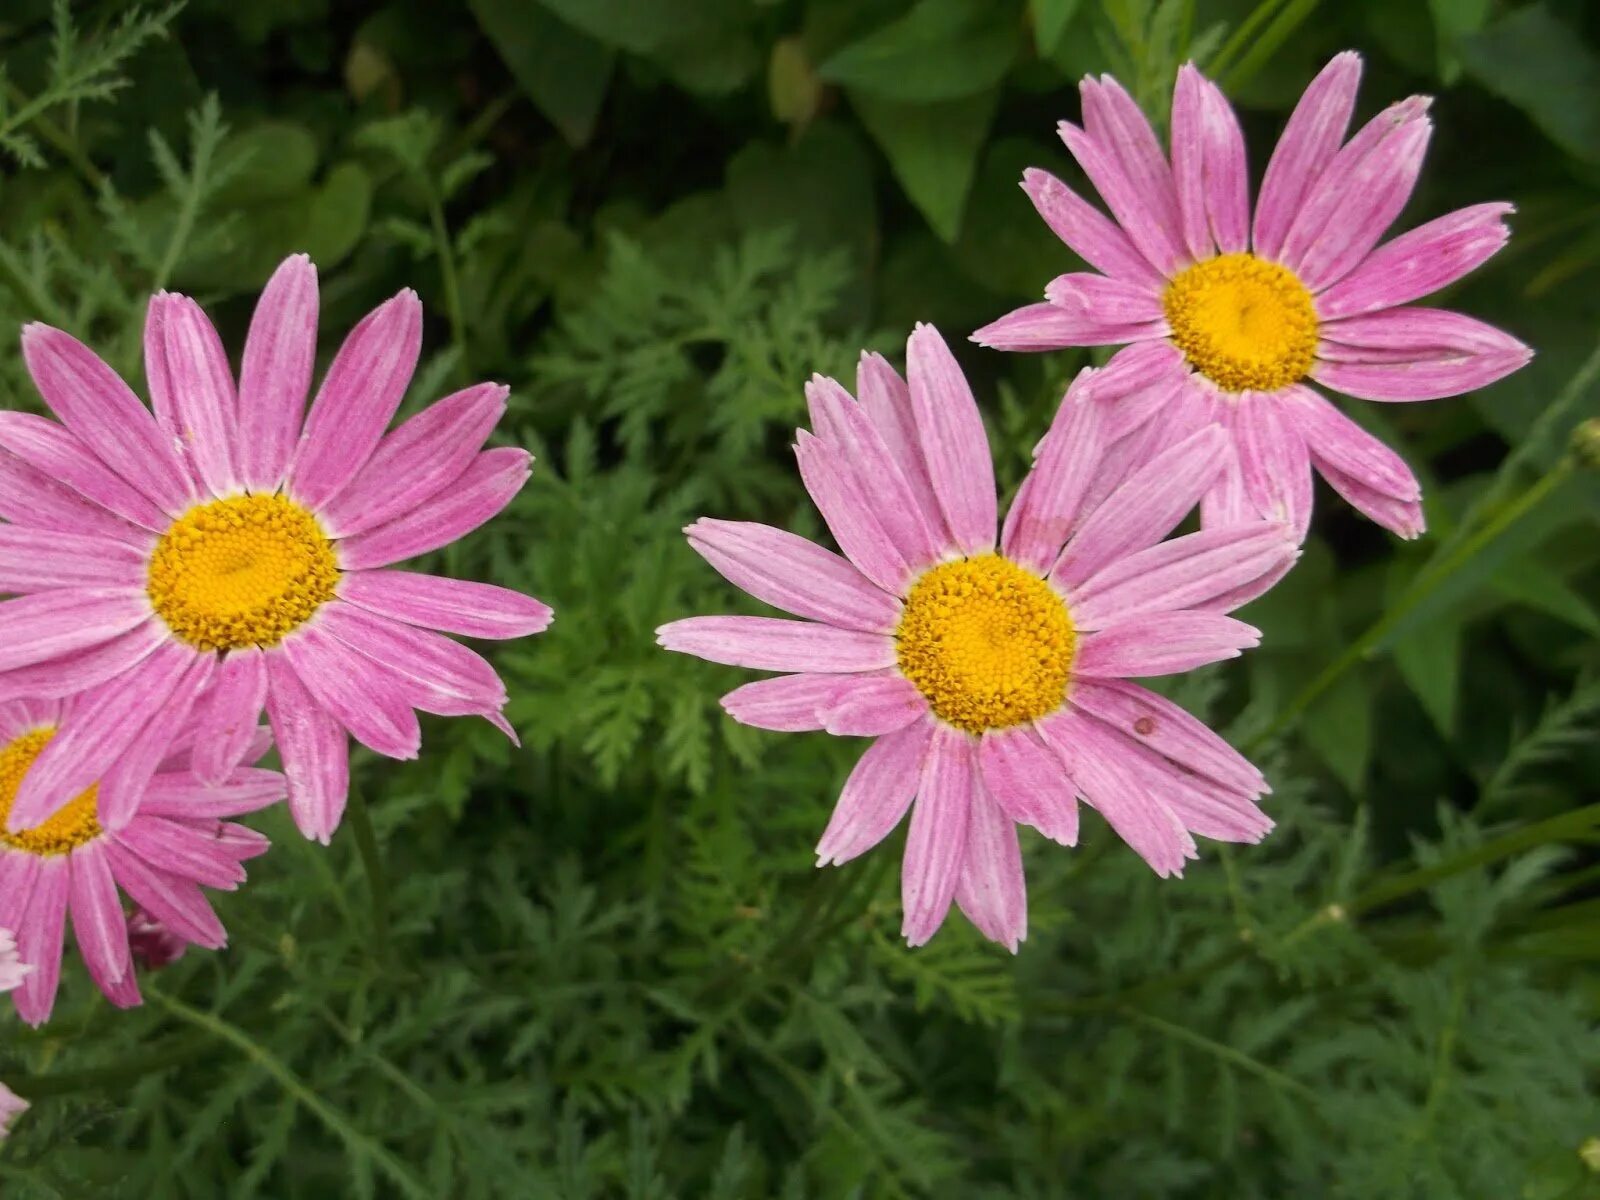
0,0 -> 1600,1200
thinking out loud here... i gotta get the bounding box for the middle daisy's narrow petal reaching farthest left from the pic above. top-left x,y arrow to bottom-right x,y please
656,616 -> 894,674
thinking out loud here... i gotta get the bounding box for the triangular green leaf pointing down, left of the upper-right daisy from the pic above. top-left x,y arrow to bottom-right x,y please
850,91 -> 1000,242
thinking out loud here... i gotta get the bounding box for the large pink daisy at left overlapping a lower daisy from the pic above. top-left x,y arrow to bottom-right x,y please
0,256 -> 550,842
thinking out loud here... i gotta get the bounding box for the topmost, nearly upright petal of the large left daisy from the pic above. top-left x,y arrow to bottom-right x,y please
238,254 -> 318,491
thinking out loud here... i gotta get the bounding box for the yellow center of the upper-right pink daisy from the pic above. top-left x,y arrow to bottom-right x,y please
1162,254 -> 1317,392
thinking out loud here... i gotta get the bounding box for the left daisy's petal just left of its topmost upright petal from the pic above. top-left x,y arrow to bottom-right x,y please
152,294 -> 238,496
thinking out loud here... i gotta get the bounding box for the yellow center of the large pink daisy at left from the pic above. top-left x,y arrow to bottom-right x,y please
147,494 -> 339,650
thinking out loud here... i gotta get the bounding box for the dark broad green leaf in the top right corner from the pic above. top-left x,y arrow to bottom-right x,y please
1459,3 -> 1600,162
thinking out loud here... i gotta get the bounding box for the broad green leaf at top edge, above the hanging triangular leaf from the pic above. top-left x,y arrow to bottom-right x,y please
818,0 -> 1019,101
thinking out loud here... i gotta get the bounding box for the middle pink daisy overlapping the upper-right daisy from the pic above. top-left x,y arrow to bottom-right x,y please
658,325 -> 1296,950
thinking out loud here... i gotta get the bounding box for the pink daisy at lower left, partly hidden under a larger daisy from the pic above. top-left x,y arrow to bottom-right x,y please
0,699 -> 285,1026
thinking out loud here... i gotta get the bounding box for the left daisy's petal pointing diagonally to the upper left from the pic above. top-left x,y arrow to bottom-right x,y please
22,323 -> 194,517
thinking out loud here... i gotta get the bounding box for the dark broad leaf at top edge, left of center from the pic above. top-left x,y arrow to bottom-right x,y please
470,0 -> 614,146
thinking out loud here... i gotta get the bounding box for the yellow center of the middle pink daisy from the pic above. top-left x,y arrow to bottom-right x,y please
894,554 -> 1077,733
